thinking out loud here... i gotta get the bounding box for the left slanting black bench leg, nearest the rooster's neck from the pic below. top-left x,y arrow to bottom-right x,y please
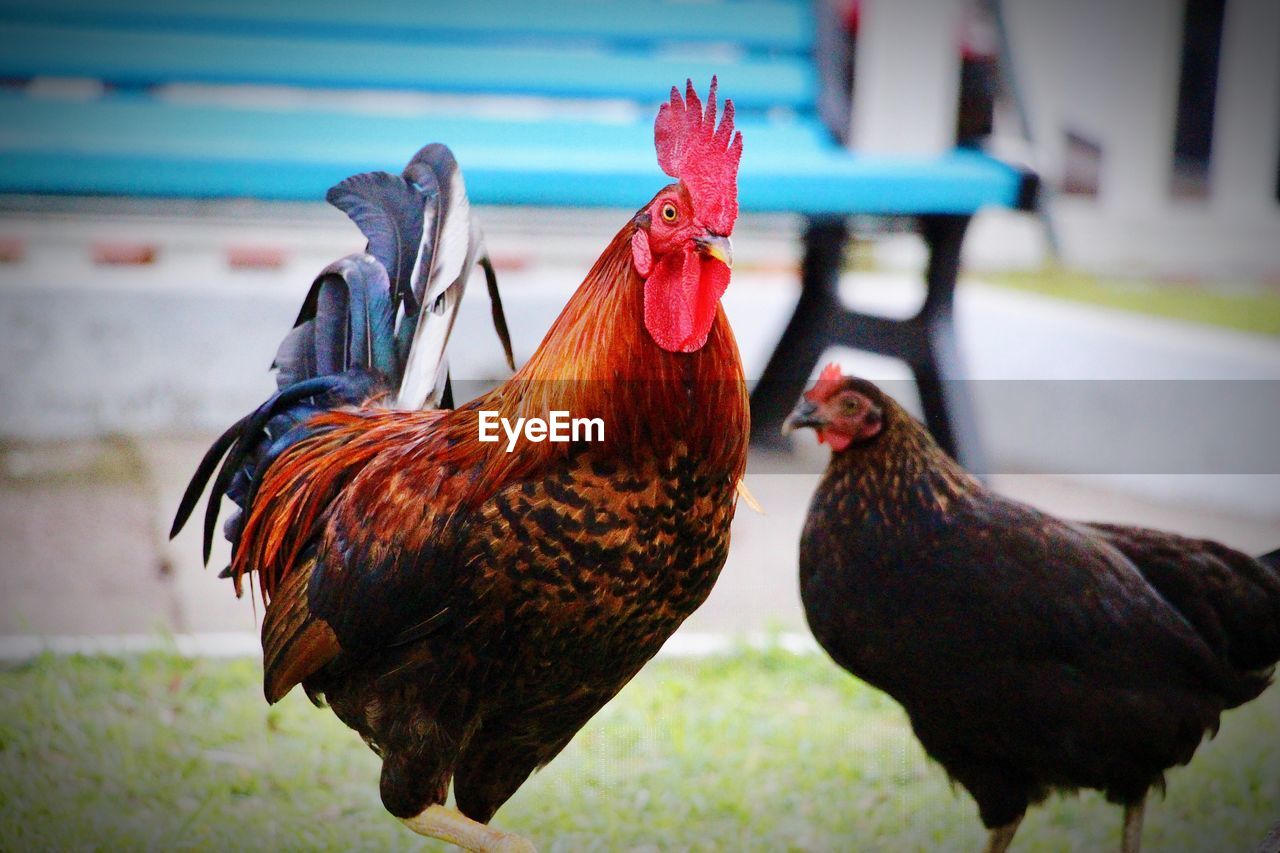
751,219 -> 849,447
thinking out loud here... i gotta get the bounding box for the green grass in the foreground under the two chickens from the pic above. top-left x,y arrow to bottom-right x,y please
0,652 -> 1280,850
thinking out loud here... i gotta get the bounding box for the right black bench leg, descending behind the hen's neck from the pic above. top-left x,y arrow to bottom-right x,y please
911,215 -> 986,474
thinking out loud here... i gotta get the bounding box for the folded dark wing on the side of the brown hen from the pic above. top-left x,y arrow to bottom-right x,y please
911,493 -> 1225,689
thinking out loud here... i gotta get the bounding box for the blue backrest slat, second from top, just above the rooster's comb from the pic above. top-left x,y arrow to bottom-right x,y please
0,24 -> 817,109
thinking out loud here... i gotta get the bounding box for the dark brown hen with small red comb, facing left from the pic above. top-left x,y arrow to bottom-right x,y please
783,365 -> 1280,853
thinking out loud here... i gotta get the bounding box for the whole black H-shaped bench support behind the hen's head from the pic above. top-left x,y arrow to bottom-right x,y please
751,208 -> 986,473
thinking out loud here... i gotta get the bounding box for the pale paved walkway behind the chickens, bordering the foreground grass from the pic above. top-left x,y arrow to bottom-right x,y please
0,435 -> 1280,637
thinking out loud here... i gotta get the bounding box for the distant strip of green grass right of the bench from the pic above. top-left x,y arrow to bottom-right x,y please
980,268 -> 1280,334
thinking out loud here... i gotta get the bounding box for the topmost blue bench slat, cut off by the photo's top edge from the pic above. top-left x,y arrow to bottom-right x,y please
0,0 -> 814,53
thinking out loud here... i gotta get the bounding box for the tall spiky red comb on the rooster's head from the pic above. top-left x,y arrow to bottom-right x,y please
653,77 -> 742,236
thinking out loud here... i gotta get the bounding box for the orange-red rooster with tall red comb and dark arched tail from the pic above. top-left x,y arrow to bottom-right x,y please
174,78 -> 749,849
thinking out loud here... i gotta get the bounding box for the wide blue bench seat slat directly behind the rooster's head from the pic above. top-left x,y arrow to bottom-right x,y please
0,95 -> 1020,214
